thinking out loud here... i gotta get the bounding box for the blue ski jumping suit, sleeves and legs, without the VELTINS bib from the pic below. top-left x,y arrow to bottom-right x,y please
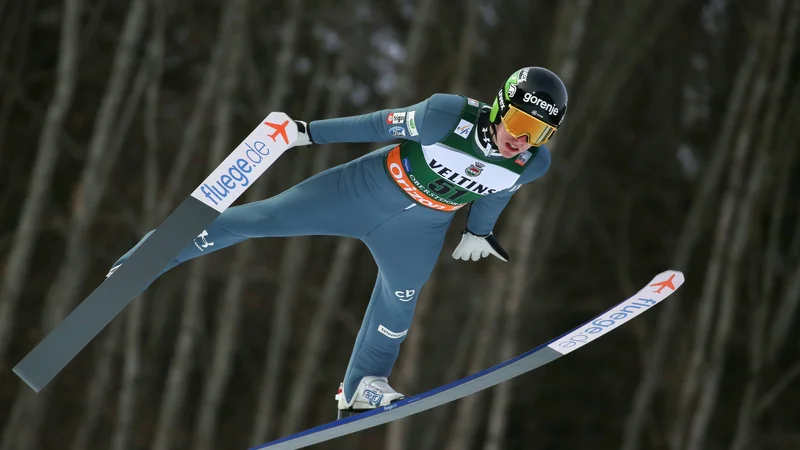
114,94 -> 550,400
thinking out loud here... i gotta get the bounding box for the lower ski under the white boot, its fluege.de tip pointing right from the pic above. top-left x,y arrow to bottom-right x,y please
251,270 -> 684,450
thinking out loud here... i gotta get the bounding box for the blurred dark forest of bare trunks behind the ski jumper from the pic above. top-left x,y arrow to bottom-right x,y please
0,0 -> 800,450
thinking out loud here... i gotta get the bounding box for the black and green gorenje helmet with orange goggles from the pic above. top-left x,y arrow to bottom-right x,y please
489,67 -> 567,146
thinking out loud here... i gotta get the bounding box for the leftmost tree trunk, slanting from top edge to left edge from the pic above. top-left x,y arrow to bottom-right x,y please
0,0 -> 83,364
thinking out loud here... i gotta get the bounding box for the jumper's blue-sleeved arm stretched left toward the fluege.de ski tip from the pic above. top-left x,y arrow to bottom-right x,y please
308,94 -> 466,145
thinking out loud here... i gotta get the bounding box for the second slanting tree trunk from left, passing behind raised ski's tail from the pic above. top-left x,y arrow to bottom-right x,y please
3,0 -> 147,450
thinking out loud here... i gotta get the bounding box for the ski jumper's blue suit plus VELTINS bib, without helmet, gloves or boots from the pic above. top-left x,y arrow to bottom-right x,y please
114,94 -> 550,400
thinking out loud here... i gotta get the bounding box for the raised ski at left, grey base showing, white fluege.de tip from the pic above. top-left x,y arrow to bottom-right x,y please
14,112 -> 297,392
